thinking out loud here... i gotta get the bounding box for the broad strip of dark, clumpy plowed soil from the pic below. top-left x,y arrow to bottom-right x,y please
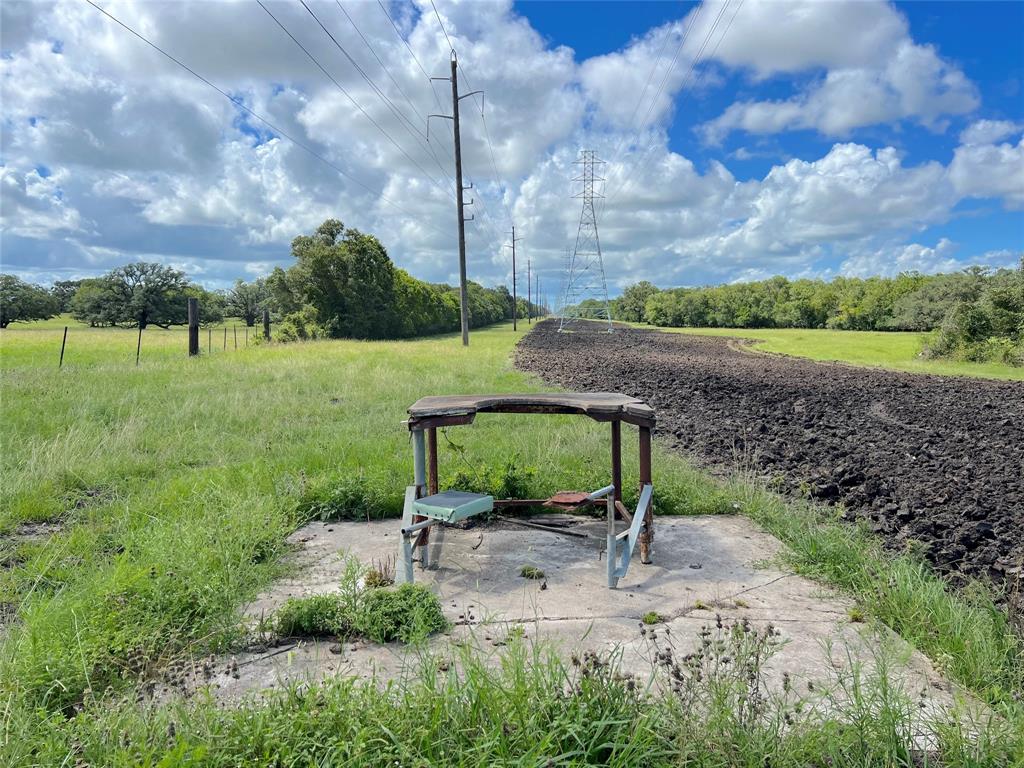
516,322 -> 1024,581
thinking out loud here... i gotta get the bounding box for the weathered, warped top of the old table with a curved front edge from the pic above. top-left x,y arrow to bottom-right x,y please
409,392 -> 654,429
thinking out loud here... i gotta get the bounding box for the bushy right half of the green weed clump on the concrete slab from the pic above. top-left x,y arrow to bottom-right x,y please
355,584 -> 450,643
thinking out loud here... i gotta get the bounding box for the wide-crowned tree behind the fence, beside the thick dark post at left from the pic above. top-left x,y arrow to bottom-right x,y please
72,261 -> 193,329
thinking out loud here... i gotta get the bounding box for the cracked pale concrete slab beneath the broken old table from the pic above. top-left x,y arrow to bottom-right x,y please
188,516 -> 952,729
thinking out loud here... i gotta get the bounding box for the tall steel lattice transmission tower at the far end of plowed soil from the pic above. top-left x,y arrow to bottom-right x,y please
558,150 -> 611,333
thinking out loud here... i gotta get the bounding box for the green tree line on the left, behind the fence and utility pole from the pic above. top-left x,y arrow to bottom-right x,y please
0,219 -> 545,341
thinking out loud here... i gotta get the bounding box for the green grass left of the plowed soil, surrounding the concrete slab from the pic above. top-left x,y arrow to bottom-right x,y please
0,321 -> 1024,765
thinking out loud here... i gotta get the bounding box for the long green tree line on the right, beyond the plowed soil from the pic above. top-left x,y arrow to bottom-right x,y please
598,256 -> 1024,365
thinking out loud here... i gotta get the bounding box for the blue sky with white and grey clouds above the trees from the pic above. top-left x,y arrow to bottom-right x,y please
0,0 -> 1024,293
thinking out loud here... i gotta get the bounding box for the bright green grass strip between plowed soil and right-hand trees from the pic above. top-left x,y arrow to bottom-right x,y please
658,328 -> 1024,381
